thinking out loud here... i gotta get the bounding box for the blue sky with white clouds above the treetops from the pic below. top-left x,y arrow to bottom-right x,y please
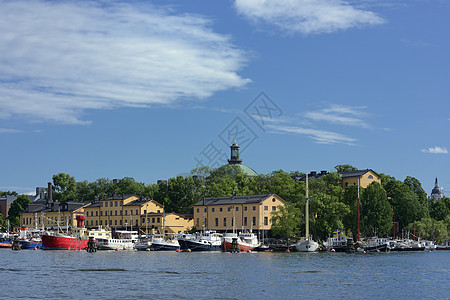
0,0 -> 450,195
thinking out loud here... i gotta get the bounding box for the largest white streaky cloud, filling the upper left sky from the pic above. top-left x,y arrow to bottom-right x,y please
0,0 -> 249,124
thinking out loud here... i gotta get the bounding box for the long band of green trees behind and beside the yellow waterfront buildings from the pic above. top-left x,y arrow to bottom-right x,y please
2,165 -> 450,241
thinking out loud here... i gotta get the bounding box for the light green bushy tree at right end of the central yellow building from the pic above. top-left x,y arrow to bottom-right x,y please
271,204 -> 301,238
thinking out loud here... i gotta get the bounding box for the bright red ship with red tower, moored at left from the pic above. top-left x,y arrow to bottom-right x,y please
42,215 -> 89,250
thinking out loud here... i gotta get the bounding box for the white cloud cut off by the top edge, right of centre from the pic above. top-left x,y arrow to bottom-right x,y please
234,0 -> 385,34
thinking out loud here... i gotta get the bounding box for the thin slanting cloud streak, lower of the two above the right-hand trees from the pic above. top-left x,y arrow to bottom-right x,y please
267,125 -> 357,145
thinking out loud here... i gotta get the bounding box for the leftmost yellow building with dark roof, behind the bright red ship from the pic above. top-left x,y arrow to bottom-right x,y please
20,199 -> 89,230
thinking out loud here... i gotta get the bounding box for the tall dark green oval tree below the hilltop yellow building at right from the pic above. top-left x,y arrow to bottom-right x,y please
361,182 -> 393,236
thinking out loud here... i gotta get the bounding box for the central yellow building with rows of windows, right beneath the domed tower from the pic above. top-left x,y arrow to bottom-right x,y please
194,194 -> 286,236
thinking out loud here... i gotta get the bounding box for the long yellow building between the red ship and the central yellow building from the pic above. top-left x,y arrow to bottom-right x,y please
85,195 -> 164,230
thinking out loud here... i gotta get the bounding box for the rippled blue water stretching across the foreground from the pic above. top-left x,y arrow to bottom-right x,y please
0,249 -> 450,299
